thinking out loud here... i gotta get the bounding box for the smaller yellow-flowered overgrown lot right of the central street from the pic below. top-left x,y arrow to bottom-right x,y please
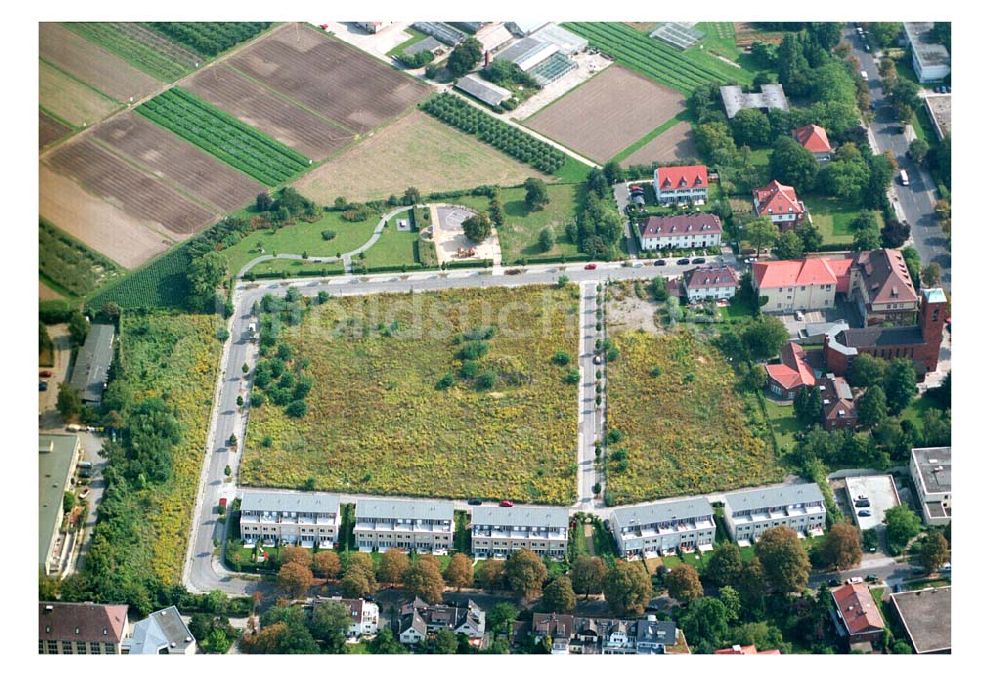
608,331 -> 783,503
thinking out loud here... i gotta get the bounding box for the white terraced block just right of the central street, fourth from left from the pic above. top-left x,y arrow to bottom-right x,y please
609,496 -> 715,558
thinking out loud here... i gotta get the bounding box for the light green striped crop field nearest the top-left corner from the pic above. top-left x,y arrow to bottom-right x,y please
63,21 -> 199,82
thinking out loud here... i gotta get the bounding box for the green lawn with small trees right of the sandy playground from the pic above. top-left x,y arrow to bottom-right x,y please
455,184 -> 582,264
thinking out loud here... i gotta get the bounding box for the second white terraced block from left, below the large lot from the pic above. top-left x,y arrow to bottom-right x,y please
354,498 -> 455,555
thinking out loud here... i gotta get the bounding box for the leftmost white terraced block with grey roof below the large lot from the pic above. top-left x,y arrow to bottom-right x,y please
240,489 -> 340,548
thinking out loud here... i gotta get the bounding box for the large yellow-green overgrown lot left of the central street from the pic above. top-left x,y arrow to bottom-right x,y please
240,287 -> 578,504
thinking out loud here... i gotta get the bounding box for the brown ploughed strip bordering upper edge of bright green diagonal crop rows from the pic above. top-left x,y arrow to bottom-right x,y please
180,63 -> 356,161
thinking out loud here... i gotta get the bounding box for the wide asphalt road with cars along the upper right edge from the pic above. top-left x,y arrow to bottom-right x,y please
845,29 -> 951,291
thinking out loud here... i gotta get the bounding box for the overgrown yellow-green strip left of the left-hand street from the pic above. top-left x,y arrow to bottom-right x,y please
115,313 -> 222,584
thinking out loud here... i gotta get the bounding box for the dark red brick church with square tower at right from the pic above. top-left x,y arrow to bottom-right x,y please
823,288 -> 948,379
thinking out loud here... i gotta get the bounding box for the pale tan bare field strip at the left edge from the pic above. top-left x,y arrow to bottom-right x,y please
38,163 -> 174,268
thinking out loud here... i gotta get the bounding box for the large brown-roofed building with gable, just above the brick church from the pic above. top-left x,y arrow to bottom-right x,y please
850,249 -> 920,327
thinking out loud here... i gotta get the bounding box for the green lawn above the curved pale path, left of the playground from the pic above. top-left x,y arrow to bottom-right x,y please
222,212 -> 381,273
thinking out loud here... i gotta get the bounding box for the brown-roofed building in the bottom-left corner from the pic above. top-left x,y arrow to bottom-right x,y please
38,602 -> 129,654
